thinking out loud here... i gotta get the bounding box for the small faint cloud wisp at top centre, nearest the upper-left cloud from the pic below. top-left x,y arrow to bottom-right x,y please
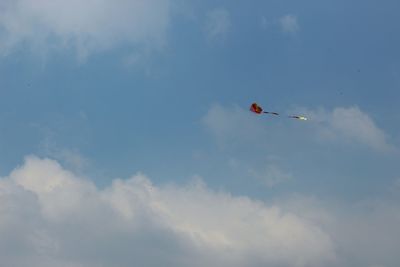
205,8 -> 231,41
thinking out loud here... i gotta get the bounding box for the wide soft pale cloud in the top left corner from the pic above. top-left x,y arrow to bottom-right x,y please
0,0 -> 170,58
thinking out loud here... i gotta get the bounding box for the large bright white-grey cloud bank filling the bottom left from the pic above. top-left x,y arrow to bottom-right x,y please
0,156 -> 335,267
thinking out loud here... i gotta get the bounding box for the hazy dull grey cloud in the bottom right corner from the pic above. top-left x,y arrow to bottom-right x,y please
331,199 -> 400,267
